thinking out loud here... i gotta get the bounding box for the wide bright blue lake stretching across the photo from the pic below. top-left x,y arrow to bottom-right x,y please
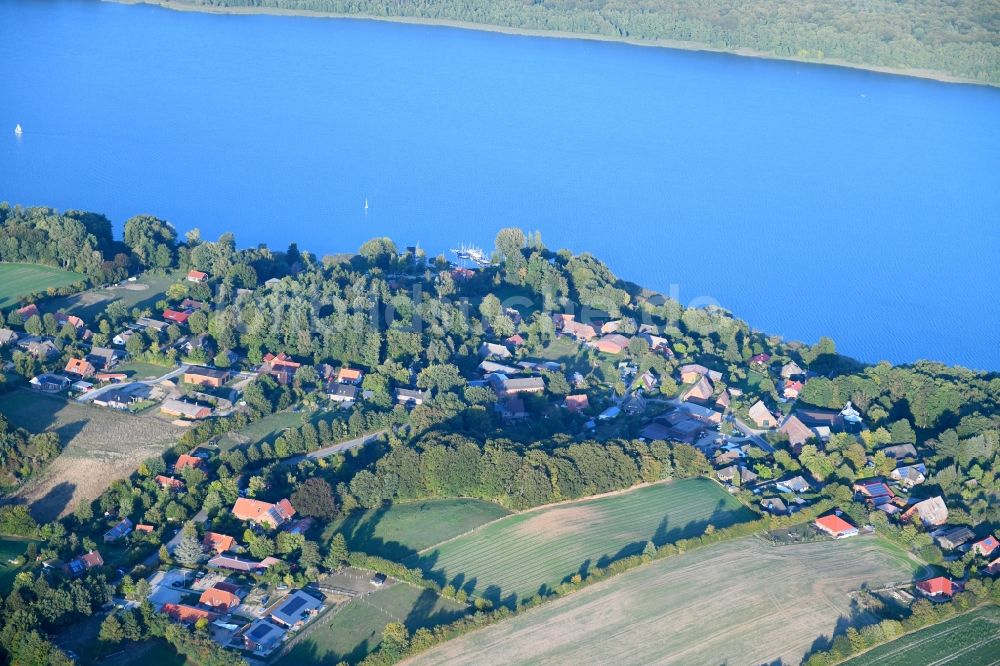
0,0 -> 1000,369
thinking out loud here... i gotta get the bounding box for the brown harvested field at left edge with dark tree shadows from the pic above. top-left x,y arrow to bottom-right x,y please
0,390 -> 180,521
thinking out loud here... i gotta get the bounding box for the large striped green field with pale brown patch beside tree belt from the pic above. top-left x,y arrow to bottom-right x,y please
406,479 -> 754,605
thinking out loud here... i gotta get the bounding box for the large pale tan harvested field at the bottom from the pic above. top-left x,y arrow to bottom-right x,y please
406,537 -> 914,666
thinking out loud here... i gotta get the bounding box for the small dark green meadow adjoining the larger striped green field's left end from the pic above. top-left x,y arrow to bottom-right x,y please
323,499 -> 509,561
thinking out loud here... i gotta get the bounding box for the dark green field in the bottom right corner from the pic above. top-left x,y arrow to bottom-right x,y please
844,606 -> 1000,666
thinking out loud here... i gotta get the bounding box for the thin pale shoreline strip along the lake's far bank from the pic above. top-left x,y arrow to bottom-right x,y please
111,0 -> 997,87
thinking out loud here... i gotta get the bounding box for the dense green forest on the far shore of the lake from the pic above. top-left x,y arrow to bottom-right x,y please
170,0 -> 1000,85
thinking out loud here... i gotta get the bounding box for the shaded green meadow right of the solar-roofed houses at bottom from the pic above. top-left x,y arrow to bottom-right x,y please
277,583 -> 465,666
